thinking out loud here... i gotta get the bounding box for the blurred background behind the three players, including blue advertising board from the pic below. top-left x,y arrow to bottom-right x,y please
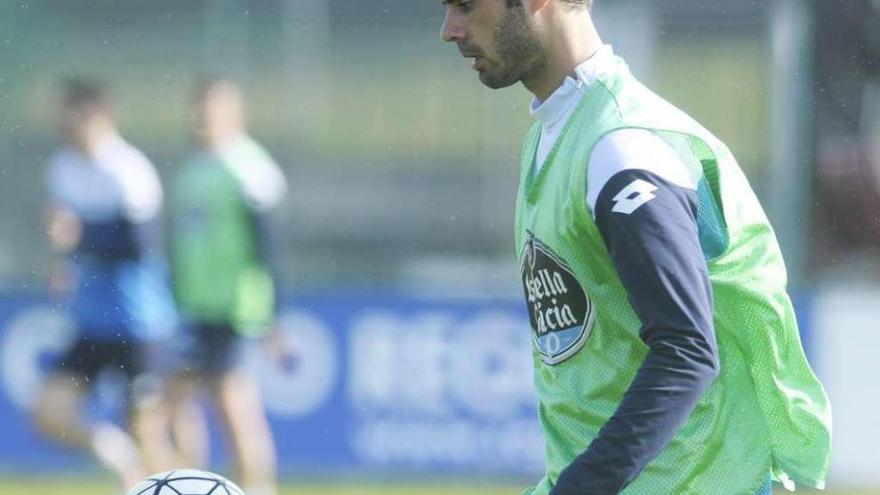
0,0 -> 880,494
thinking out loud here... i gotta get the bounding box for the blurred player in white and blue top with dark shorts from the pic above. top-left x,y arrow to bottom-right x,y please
34,80 -> 176,486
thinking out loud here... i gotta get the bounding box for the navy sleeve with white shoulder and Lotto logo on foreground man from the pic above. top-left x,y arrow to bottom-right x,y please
552,131 -> 719,495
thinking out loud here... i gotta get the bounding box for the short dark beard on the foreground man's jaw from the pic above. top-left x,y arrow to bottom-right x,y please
480,4 -> 547,89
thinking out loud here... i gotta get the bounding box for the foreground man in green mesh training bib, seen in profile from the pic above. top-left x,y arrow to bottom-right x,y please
442,0 -> 830,495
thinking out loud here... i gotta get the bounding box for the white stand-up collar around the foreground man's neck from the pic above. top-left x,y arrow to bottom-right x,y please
529,45 -> 614,125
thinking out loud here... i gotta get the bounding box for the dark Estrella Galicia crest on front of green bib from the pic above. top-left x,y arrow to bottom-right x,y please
522,233 -> 594,365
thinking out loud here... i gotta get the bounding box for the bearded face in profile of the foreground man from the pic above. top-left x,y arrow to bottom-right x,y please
442,0 -> 545,89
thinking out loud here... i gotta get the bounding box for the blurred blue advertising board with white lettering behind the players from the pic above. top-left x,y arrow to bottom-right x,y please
0,292 -> 543,476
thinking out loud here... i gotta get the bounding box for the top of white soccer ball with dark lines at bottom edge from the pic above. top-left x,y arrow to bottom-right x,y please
127,469 -> 245,495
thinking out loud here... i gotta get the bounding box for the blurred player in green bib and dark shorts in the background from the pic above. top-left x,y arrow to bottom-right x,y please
172,79 -> 286,495
